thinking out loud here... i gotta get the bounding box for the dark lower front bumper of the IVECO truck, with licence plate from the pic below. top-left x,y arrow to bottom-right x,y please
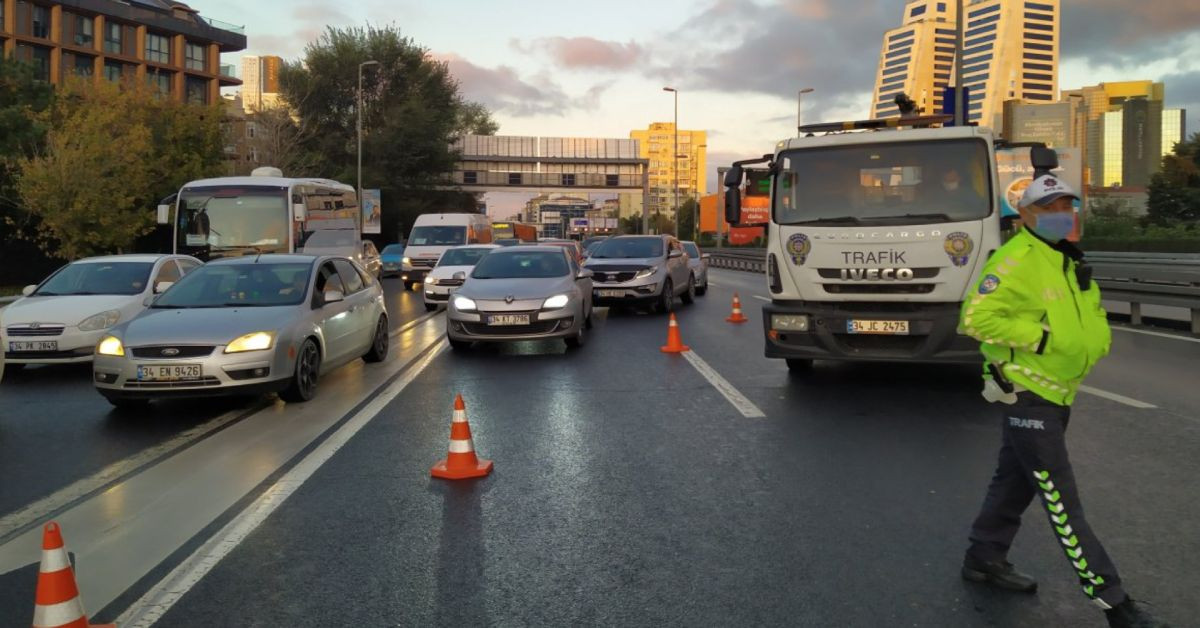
762,301 -> 983,364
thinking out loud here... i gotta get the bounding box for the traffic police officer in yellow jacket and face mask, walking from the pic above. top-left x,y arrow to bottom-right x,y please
961,174 -> 1165,627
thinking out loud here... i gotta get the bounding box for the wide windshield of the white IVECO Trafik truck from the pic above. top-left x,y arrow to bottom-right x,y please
774,139 -> 992,226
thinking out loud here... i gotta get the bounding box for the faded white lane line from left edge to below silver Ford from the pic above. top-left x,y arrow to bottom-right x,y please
0,405 -> 253,539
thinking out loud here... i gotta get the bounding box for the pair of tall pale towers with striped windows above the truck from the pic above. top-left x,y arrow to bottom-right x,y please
871,0 -> 1061,128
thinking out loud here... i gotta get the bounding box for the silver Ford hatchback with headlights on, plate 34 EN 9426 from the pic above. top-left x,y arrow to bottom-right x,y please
92,255 -> 388,407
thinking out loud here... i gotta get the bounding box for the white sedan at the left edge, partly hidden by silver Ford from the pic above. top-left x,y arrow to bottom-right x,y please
0,255 -> 202,367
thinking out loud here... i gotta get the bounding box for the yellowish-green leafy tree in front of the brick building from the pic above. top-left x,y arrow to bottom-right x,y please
17,80 -> 223,258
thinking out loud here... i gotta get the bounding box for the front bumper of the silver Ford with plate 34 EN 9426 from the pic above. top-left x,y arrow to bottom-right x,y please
92,347 -> 293,399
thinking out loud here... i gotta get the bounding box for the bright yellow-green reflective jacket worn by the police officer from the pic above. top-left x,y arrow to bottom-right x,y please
961,229 -> 1112,406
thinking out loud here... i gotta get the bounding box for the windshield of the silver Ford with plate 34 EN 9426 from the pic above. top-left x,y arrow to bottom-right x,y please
151,262 -> 312,310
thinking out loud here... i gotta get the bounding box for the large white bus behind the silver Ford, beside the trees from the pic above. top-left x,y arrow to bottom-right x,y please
158,167 -> 362,261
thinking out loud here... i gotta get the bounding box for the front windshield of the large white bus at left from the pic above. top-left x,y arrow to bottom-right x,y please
175,186 -> 290,259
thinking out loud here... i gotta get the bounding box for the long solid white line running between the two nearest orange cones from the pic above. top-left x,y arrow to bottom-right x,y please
116,340 -> 448,628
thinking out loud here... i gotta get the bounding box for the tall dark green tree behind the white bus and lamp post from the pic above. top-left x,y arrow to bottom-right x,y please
280,26 -> 496,241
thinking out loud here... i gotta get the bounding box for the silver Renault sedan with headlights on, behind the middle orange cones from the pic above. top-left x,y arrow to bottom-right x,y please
446,246 -> 592,349
